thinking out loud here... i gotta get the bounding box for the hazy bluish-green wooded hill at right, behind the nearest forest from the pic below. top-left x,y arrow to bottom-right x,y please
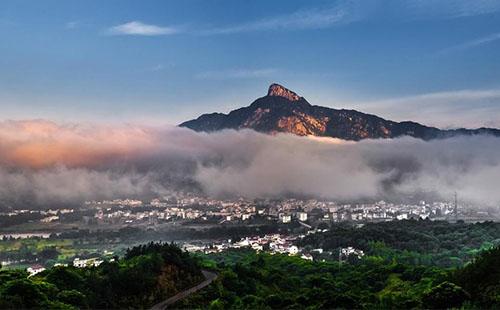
299,220 -> 500,267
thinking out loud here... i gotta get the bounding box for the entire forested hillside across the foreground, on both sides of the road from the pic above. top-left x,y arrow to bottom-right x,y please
0,220 -> 500,309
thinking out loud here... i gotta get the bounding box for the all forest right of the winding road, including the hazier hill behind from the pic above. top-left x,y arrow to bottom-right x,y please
177,220 -> 500,309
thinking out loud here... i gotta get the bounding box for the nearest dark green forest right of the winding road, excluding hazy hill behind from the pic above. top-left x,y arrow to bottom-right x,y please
176,248 -> 500,309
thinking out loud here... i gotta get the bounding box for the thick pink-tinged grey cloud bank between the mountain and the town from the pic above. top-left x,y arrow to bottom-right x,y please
0,120 -> 500,208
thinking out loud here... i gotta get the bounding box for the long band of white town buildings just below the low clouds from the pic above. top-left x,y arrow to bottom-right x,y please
82,197 -> 480,225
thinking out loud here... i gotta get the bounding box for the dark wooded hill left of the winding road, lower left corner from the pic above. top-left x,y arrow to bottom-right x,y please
0,243 -> 203,309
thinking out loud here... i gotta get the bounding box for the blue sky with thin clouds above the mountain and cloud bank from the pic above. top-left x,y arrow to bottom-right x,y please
0,0 -> 500,127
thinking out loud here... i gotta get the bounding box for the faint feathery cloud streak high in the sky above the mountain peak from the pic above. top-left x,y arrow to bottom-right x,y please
200,1 -> 363,35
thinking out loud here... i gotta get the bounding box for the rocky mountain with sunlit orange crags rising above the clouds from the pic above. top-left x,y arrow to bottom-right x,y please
179,84 -> 500,140
